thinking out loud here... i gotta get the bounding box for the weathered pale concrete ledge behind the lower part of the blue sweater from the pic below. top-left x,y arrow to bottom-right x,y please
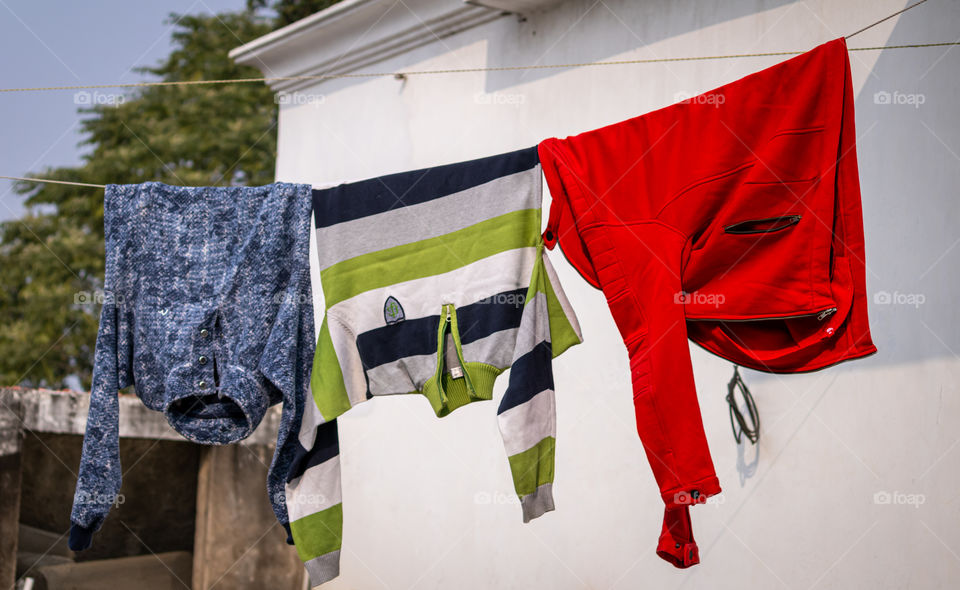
0,387 -> 280,448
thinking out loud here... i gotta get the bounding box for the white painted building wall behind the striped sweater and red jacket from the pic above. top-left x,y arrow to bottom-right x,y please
277,0 -> 960,590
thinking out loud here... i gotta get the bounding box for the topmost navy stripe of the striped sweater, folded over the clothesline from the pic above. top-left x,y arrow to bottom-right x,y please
313,146 -> 540,227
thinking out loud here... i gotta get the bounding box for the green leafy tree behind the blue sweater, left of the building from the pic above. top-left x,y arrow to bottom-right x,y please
0,13 -> 277,387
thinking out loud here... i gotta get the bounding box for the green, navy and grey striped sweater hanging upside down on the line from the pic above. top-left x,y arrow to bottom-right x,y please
286,148 -> 581,585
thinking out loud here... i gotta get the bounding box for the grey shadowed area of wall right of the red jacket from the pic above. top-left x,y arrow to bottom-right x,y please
852,2 -> 960,364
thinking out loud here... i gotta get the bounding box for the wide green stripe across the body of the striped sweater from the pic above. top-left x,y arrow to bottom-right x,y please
320,209 -> 540,309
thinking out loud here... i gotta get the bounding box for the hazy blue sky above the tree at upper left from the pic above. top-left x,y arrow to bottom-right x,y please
0,0 -> 251,220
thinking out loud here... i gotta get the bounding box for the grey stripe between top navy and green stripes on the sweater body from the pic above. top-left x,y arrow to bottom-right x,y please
317,165 -> 541,270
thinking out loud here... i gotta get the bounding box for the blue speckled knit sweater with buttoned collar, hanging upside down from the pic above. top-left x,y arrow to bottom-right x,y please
70,182 -> 315,550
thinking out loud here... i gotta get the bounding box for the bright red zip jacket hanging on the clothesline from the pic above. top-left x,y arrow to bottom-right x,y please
539,39 -> 876,567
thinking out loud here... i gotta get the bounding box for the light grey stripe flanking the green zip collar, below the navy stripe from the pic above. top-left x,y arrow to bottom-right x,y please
367,328 -> 518,395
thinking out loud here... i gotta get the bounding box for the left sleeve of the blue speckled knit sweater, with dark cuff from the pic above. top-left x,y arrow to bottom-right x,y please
69,293 -> 132,551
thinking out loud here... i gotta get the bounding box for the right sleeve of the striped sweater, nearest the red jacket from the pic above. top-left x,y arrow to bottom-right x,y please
497,247 -> 581,522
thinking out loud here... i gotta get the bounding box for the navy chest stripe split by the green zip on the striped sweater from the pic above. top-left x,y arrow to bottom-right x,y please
357,289 -> 527,369
